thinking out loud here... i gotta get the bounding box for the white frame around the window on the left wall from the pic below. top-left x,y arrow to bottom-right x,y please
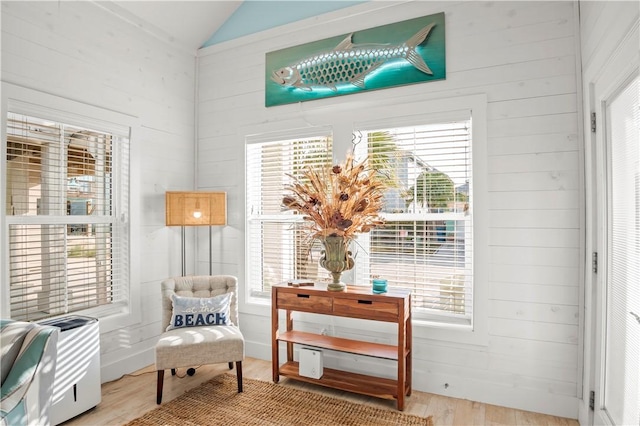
0,82 -> 141,332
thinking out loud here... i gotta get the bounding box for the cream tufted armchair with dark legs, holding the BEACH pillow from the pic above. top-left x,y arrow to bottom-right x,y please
156,275 -> 244,404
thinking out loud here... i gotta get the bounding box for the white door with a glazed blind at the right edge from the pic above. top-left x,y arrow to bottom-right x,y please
594,72 -> 640,425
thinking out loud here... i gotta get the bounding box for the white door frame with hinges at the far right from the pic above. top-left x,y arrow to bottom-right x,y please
579,20 -> 640,425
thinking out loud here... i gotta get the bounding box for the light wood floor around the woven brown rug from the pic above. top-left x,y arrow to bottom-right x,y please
64,358 -> 578,426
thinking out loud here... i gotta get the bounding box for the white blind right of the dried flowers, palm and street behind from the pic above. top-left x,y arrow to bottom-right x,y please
354,118 -> 473,325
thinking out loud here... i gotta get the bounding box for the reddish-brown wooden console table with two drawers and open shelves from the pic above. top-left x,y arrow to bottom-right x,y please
271,285 -> 412,410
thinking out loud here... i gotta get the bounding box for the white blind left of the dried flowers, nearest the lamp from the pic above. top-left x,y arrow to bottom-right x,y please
246,134 -> 332,298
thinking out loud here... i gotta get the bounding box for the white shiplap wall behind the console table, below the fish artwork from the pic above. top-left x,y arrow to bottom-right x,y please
197,1 -> 582,424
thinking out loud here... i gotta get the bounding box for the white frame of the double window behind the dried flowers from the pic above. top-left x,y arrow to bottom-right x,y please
240,94 -> 489,346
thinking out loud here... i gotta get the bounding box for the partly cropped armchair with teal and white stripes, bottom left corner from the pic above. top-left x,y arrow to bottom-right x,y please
0,320 -> 59,426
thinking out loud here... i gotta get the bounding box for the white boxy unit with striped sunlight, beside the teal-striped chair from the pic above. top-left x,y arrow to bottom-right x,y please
41,315 -> 102,425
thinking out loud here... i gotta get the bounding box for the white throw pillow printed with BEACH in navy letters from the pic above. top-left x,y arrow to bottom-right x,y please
167,293 -> 232,331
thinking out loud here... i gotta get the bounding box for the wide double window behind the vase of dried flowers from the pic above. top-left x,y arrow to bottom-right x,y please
246,95 -> 488,332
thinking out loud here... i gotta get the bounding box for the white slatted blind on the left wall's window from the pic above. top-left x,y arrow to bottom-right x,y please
5,112 -> 129,321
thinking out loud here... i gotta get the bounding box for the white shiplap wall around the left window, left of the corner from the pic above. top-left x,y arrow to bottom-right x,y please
1,1 -> 195,381
